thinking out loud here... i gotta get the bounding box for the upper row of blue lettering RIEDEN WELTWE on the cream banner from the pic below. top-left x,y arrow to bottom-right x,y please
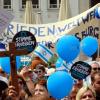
7,10 -> 95,37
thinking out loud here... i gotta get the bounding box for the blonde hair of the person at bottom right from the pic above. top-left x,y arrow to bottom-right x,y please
76,85 -> 96,100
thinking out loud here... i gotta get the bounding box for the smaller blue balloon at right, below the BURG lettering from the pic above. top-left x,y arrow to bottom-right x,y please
81,36 -> 98,57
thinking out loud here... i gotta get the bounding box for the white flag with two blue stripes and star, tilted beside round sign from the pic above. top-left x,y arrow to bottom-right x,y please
34,44 -> 53,63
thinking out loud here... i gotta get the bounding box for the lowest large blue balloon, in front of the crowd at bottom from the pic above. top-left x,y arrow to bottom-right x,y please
47,71 -> 74,99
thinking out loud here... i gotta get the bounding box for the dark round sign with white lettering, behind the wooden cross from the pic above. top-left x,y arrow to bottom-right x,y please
12,31 -> 36,53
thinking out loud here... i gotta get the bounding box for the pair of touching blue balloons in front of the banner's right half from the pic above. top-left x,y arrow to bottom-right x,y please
56,35 -> 98,63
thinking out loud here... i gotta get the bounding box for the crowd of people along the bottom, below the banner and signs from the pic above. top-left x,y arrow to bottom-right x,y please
0,55 -> 100,100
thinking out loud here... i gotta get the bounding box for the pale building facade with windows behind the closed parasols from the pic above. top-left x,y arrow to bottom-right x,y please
0,0 -> 89,23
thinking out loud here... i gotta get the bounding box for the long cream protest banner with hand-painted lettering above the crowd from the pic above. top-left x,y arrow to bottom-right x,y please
0,3 -> 100,57
